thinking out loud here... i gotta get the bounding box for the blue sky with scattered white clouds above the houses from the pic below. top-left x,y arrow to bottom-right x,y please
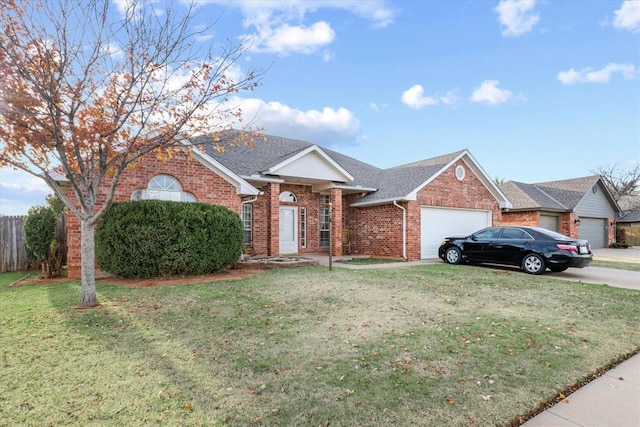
0,0 -> 640,215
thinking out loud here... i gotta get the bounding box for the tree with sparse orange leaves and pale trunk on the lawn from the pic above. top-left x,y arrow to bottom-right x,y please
0,0 -> 260,307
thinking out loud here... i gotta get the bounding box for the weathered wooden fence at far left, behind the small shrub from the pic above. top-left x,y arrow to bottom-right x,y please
0,214 -> 67,273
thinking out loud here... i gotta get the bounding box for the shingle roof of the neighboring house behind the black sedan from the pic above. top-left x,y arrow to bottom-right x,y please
500,175 -> 600,211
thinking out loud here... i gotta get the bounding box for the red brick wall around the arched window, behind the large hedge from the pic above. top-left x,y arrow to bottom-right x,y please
67,153 -> 241,278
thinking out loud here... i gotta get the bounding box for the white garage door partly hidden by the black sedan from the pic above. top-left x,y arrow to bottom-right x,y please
420,207 -> 491,259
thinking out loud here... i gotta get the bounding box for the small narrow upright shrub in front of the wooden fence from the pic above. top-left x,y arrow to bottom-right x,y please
24,206 -> 56,278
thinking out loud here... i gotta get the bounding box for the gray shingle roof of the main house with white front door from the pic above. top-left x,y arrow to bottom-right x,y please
194,131 -> 464,203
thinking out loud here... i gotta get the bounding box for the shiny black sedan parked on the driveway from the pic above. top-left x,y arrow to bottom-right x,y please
438,226 -> 593,274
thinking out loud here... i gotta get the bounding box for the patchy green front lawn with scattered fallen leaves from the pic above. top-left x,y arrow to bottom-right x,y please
0,264 -> 640,426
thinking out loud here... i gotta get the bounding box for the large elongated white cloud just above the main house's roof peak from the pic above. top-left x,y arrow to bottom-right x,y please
228,97 -> 360,146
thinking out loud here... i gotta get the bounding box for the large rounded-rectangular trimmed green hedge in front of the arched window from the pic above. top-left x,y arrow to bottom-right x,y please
95,200 -> 244,278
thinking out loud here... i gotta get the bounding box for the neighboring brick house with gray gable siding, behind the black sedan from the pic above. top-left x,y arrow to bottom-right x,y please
500,175 -> 620,248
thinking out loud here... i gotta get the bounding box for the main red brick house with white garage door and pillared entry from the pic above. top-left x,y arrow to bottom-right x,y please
62,132 -> 511,277
